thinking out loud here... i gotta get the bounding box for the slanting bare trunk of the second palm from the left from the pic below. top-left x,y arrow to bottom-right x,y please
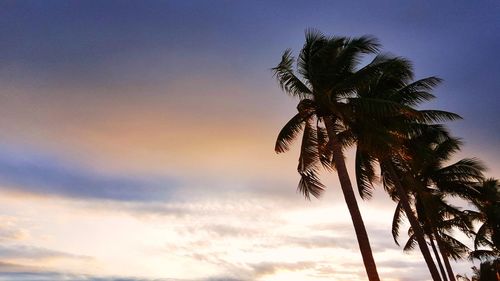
387,161 -> 441,281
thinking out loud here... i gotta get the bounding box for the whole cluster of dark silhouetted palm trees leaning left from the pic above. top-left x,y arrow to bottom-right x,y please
273,30 -> 500,281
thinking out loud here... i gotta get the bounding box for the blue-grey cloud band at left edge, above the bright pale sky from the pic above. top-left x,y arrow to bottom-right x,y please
0,147 -> 176,202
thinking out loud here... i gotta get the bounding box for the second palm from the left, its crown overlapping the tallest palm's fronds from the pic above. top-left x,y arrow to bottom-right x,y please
349,59 -> 460,280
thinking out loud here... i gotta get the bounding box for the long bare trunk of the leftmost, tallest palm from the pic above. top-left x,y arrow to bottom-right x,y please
325,117 -> 380,281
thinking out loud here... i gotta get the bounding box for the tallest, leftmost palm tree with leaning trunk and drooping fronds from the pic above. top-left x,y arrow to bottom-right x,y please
273,30 -> 386,281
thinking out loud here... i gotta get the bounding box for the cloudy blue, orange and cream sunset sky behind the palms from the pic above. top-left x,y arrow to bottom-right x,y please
0,0 -> 500,281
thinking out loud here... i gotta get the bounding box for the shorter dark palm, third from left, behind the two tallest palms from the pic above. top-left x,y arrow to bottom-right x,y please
393,127 -> 485,281
